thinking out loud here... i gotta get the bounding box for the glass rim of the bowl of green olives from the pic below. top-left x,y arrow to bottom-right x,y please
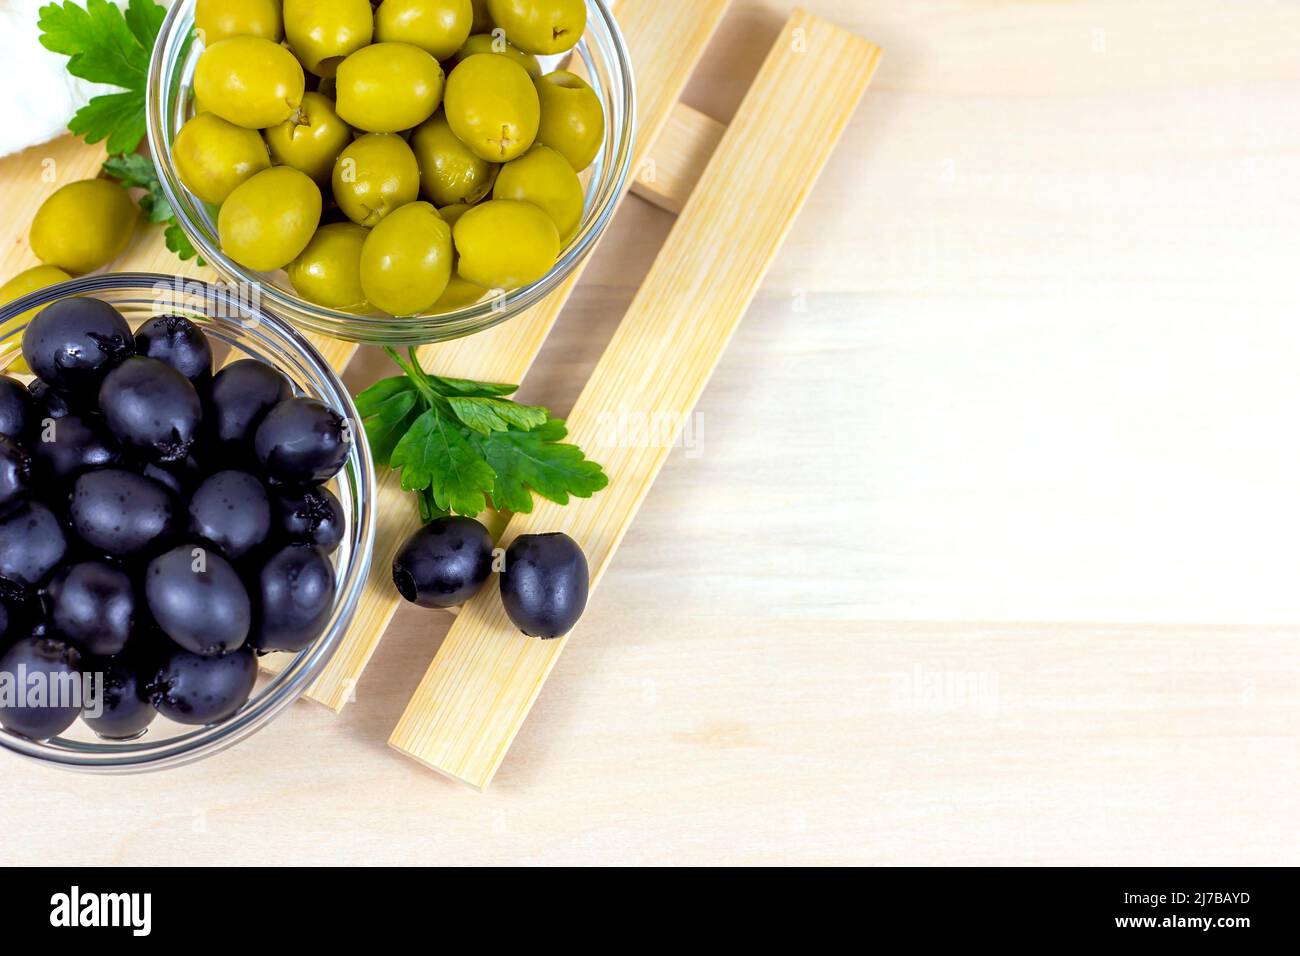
146,0 -> 637,345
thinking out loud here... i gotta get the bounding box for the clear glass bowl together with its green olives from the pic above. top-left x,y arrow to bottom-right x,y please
148,0 -> 636,345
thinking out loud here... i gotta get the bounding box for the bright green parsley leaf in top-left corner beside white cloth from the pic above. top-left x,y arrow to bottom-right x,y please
36,0 -> 166,153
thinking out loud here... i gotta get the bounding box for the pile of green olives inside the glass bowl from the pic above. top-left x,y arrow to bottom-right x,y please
172,0 -> 605,316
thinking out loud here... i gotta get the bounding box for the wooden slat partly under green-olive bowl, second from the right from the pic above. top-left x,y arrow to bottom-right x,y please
299,0 -> 728,710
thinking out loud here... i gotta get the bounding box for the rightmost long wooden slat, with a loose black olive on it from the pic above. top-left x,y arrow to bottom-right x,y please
389,12 -> 880,790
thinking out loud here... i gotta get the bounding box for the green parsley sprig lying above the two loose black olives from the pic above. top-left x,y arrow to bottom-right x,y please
356,349 -> 608,522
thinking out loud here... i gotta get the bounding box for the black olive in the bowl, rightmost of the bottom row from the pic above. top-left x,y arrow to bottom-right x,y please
150,648 -> 257,723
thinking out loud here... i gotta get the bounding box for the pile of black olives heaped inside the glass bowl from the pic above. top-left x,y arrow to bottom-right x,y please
0,298 -> 351,740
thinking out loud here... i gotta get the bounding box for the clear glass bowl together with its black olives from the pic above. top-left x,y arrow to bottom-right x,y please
0,273 -> 374,771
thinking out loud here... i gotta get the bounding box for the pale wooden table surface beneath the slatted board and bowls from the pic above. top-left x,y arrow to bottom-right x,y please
0,0 -> 1300,864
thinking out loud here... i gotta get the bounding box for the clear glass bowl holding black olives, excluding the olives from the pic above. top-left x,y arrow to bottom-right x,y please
0,273 -> 374,773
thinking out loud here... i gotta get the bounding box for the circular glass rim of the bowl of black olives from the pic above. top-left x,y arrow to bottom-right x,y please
0,272 -> 377,774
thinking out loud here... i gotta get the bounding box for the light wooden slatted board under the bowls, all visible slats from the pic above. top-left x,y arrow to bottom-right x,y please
0,0 -> 880,788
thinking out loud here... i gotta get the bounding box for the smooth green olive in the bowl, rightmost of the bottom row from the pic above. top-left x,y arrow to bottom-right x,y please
455,199 -> 560,289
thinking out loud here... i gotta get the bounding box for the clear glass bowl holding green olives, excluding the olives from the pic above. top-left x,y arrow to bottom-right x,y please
147,0 -> 636,345
